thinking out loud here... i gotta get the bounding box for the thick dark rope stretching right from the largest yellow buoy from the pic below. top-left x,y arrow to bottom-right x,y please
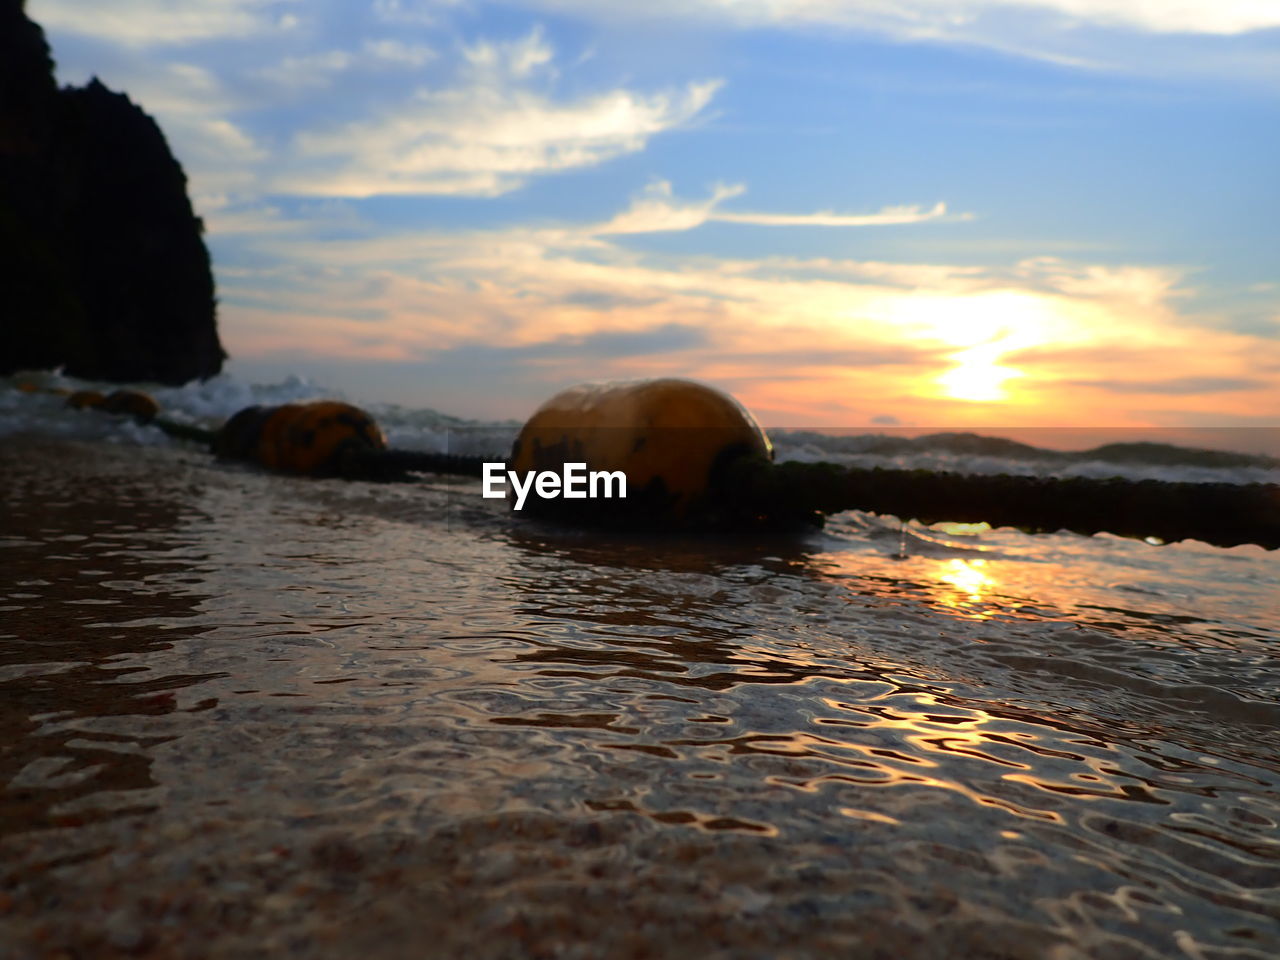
722,460 -> 1280,550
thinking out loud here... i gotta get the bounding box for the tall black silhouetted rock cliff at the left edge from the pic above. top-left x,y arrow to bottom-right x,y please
0,0 -> 225,384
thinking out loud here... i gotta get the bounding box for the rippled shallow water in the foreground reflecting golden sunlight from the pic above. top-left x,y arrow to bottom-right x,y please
0,440 -> 1280,957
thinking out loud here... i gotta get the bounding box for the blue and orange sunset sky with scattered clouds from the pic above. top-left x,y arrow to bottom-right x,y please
27,0 -> 1280,430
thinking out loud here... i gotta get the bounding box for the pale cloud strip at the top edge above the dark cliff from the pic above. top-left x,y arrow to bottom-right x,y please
29,0 -> 288,47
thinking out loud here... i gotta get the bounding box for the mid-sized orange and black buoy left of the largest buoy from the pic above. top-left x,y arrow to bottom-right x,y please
214,401 -> 387,476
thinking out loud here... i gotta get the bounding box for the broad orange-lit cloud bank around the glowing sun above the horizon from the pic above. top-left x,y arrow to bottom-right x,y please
223,188 -> 1280,429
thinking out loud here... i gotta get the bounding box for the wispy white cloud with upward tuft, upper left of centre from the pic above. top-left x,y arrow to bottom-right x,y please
274,31 -> 721,197
